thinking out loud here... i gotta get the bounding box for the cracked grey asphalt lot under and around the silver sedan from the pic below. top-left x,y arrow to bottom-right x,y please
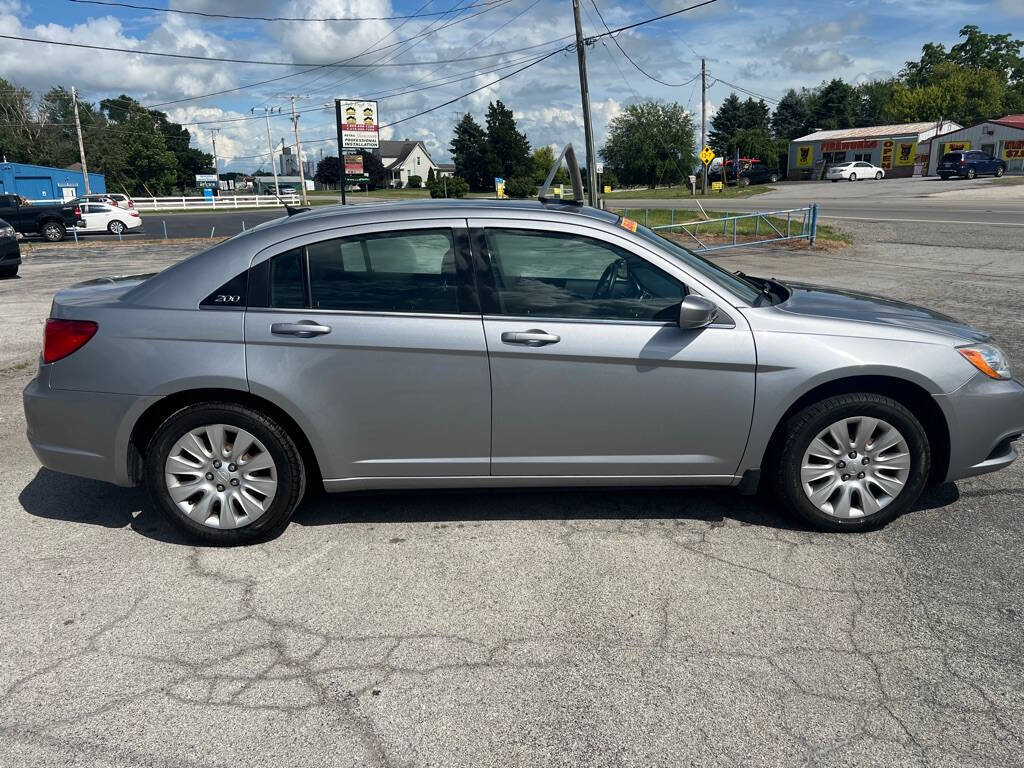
0,221 -> 1024,768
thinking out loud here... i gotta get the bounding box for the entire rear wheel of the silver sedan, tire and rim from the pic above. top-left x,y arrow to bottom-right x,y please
145,402 -> 305,545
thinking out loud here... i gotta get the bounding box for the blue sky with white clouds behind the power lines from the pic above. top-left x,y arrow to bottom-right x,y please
0,0 -> 1024,172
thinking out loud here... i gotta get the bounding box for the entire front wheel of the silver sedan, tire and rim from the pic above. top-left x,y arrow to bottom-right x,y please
773,393 -> 931,531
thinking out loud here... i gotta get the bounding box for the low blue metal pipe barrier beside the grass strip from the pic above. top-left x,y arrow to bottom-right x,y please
623,203 -> 818,251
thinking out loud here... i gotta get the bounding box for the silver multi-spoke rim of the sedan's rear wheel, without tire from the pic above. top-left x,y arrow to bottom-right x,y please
164,424 -> 278,528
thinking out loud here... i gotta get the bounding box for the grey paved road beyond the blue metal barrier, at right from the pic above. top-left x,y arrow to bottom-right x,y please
608,177 -> 1024,227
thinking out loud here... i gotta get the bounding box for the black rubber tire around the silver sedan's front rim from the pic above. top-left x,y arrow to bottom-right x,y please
770,392 -> 932,532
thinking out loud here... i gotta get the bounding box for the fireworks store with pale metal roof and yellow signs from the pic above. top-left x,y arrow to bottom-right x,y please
787,121 -> 961,179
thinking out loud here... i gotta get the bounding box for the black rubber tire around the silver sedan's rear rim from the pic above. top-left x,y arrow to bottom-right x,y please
144,402 -> 306,546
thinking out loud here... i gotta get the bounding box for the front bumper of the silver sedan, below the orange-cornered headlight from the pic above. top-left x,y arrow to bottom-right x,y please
936,374 -> 1024,481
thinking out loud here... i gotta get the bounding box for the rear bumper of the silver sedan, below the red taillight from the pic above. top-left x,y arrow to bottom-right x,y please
22,367 -> 159,485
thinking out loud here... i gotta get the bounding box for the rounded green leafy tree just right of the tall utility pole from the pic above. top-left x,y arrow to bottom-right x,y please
599,100 -> 696,188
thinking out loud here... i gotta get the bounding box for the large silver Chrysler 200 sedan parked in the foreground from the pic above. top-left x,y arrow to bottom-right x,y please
24,199 -> 1024,544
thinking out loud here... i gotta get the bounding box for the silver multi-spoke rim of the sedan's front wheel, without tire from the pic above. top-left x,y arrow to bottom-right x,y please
800,416 -> 910,519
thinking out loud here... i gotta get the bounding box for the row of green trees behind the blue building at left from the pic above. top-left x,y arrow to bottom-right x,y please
0,78 -> 214,196
